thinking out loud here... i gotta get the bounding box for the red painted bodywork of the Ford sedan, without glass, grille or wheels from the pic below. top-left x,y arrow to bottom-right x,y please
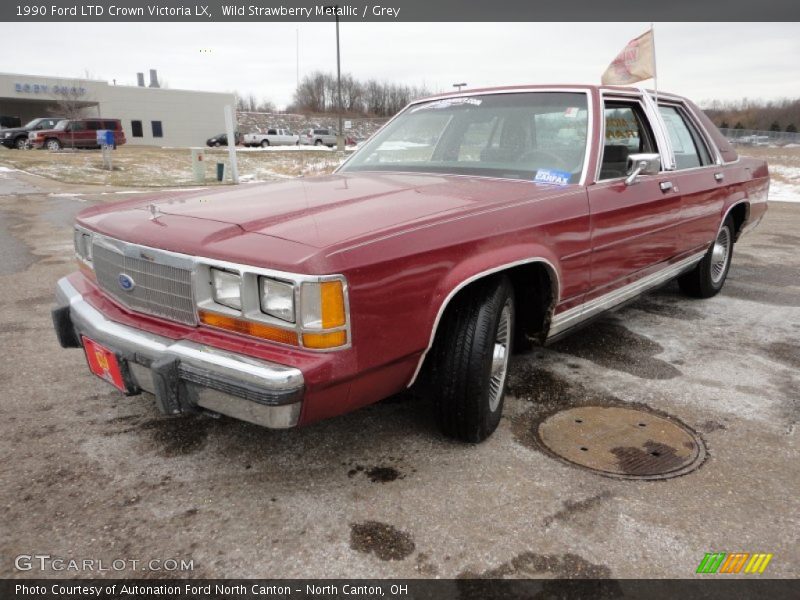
71,86 -> 768,424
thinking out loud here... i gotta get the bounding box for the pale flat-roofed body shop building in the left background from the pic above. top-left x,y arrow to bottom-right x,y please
0,70 -> 236,146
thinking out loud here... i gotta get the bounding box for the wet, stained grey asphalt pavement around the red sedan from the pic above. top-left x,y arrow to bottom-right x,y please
0,166 -> 800,578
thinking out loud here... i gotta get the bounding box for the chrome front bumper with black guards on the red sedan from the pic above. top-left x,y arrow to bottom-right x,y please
53,277 -> 304,429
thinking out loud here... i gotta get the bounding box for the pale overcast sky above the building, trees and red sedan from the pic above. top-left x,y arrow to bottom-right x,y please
6,22 -> 800,107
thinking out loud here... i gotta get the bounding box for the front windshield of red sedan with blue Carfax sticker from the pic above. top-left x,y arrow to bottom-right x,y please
341,92 -> 588,183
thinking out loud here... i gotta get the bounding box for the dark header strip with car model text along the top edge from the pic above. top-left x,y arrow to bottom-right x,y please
0,0 -> 800,23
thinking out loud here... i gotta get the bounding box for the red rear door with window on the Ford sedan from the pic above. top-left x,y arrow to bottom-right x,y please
658,102 -> 732,254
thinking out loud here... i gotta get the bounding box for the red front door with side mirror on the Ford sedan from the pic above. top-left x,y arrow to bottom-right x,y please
587,96 -> 681,300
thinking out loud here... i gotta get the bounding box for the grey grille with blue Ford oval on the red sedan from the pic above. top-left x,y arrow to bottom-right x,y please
92,244 -> 197,325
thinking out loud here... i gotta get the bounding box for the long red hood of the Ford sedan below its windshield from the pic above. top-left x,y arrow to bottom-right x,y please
130,173 -> 563,248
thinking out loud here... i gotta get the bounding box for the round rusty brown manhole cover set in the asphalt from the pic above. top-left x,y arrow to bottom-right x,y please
539,406 -> 706,479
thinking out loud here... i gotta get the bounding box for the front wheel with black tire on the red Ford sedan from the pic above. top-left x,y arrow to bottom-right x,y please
429,276 -> 514,443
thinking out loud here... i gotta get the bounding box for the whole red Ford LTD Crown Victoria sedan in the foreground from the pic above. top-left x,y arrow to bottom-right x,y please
53,86 -> 769,442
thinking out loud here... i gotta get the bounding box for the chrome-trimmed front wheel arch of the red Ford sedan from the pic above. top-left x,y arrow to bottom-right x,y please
407,252 -> 562,387
